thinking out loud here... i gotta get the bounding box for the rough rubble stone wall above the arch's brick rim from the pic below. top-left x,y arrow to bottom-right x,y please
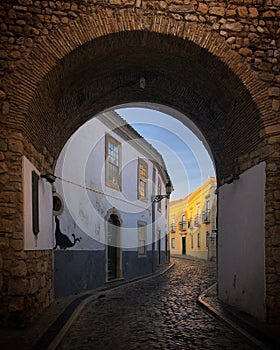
0,0 -> 280,120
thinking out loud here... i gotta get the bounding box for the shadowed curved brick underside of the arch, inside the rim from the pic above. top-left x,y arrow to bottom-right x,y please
25,31 -> 262,178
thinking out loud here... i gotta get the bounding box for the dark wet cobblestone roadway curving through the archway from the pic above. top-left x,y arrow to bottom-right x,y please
58,259 -> 257,350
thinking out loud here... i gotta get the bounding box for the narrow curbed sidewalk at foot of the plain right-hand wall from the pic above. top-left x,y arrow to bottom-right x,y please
197,283 -> 274,350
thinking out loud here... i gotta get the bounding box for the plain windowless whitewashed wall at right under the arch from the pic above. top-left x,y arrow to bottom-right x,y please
218,163 -> 265,320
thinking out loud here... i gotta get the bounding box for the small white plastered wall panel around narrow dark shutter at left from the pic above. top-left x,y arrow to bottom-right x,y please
23,157 -> 54,250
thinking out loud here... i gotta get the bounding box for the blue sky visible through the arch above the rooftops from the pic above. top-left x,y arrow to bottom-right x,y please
116,108 -> 215,200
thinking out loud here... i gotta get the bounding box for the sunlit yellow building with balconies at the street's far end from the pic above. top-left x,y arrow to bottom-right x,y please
169,177 -> 217,260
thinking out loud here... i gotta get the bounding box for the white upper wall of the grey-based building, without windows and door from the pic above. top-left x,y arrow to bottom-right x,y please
55,118 -> 168,250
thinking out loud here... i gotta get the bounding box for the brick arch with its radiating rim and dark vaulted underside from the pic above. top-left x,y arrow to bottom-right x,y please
10,10 -> 270,179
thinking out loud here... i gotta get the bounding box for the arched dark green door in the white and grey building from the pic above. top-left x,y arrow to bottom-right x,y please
107,215 -> 120,281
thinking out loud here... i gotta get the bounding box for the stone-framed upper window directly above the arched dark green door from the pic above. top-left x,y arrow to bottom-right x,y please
105,134 -> 121,191
